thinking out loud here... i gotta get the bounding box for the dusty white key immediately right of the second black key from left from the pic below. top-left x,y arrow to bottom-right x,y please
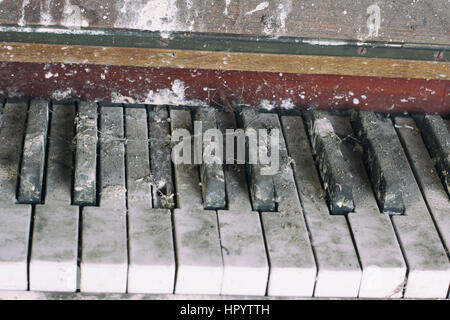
80,106 -> 128,292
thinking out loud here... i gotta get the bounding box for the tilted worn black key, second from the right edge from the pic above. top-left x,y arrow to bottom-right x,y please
351,111 -> 405,214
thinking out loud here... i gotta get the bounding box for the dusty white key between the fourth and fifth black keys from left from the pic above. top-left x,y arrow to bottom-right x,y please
217,112 -> 269,295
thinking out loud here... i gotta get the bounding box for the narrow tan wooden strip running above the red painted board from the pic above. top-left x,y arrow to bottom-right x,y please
0,43 -> 450,80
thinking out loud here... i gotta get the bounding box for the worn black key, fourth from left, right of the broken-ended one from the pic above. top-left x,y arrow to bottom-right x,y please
195,108 -> 226,209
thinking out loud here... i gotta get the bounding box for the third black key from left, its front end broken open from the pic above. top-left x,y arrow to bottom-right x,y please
147,106 -> 175,209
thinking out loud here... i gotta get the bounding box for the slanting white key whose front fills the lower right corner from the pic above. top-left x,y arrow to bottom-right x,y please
379,115 -> 450,298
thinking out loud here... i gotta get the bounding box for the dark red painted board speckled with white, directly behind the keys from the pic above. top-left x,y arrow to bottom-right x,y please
0,62 -> 450,114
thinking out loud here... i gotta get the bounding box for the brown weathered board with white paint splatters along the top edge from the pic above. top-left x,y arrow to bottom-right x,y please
0,0 -> 450,45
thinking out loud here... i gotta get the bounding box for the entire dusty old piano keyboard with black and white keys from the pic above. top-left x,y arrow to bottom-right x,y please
0,100 -> 450,298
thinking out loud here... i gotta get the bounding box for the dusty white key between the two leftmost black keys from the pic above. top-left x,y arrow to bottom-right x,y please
30,105 -> 78,291
